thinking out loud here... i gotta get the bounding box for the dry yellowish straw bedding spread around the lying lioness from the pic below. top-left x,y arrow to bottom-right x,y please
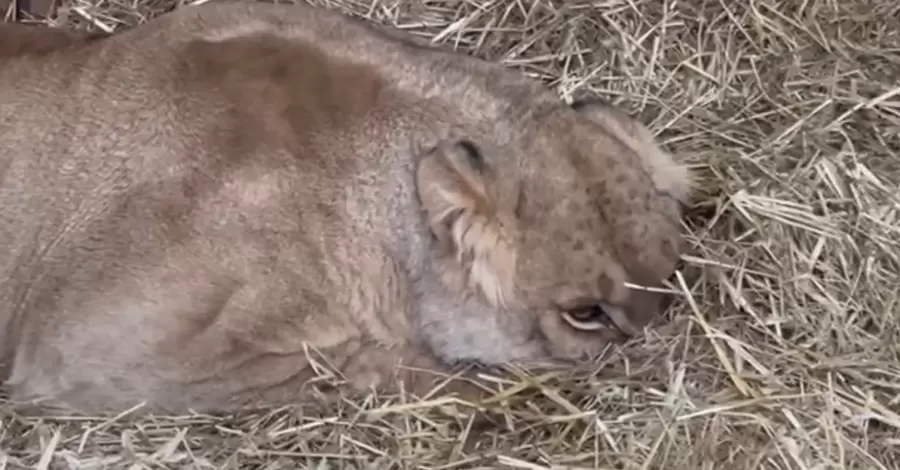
0,0 -> 900,470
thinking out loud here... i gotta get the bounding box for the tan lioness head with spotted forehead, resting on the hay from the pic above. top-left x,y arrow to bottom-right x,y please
417,101 -> 689,362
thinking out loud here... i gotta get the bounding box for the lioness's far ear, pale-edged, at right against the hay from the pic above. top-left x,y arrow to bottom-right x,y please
571,98 -> 692,203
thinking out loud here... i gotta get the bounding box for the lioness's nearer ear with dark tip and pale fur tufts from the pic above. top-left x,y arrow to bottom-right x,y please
416,140 -> 516,308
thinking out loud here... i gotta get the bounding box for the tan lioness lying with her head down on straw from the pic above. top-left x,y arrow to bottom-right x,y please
0,2 -> 689,412
